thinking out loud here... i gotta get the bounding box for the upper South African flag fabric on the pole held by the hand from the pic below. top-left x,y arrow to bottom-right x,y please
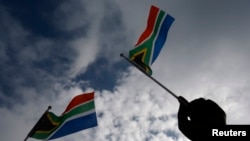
129,5 -> 174,75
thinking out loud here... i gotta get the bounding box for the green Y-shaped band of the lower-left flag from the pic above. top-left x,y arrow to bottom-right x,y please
32,101 -> 95,139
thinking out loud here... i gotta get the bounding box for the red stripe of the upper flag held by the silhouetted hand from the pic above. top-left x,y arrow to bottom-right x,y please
135,5 -> 159,46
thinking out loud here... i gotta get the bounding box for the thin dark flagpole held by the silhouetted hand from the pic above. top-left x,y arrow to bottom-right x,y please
120,53 -> 188,104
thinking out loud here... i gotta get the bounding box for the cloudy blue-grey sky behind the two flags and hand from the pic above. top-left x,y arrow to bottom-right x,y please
0,0 -> 250,141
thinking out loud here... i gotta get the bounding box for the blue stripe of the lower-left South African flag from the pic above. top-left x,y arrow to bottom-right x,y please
49,112 -> 97,140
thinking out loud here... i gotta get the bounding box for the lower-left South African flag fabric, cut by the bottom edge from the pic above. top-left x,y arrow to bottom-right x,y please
29,92 -> 97,140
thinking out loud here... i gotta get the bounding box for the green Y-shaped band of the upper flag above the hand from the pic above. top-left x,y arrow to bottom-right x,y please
130,11 -> 165,66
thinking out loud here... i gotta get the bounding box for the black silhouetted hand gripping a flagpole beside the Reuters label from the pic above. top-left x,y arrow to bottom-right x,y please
178,96 -> 226,141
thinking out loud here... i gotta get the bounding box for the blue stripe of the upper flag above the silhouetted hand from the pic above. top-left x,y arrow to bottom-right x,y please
151,15 -> 174,64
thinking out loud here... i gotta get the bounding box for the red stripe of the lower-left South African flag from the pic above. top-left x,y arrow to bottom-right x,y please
63,92 -> 94,114
